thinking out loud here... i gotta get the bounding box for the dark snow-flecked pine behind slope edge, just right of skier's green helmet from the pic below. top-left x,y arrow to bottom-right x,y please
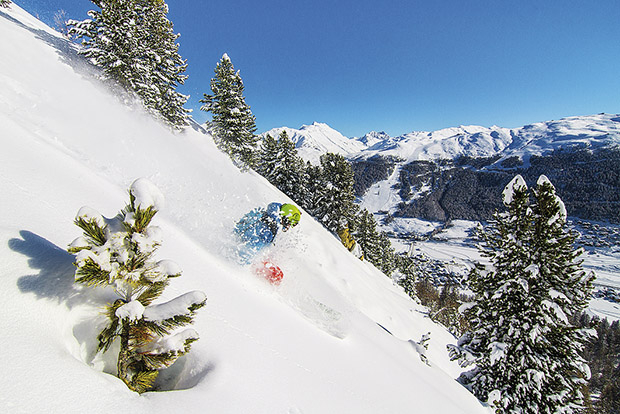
315,152 -> 358,233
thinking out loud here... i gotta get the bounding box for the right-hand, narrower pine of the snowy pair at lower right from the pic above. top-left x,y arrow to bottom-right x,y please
532,175 -> 594,413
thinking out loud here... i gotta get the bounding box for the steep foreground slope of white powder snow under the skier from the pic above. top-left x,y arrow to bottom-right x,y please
0,6 -> 489,414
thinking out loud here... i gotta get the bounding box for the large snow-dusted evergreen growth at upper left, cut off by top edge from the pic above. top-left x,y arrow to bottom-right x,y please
67,0 -> 188,128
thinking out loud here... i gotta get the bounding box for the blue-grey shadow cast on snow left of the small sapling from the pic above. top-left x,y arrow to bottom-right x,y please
8,230 -> 88,308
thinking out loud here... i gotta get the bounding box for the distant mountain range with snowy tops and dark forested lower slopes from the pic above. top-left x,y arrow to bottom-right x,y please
268,114 -> 620,223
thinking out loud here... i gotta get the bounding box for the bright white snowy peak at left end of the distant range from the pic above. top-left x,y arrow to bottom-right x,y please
261,122 -> 367,164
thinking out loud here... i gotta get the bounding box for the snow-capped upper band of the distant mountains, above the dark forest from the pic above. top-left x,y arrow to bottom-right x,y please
261,114 -> 620,168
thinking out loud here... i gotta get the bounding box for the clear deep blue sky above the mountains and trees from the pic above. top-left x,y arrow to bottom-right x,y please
16,0 -> 620,137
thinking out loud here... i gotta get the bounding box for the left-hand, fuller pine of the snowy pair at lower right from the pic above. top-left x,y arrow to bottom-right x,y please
452,176 -> 548,413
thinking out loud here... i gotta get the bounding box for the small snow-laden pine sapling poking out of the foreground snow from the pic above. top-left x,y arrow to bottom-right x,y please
68,178 -> 206,393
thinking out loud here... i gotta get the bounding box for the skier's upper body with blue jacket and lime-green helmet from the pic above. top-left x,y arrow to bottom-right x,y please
234,203 -> 301,264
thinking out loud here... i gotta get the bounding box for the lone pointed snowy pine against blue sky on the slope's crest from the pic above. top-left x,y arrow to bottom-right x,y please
200,53 -> 258,168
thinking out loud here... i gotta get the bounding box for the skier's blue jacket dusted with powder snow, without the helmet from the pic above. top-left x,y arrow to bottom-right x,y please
234,203 -> 282,263
